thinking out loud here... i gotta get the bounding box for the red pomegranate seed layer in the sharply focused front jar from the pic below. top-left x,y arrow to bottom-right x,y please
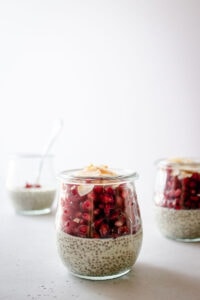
60,180 -> 139,238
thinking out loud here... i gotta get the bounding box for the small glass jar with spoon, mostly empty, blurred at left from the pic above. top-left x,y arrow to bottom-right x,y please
6,153 -> 56,215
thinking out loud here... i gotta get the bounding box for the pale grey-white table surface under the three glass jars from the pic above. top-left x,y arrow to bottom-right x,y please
0,192 -> 200,300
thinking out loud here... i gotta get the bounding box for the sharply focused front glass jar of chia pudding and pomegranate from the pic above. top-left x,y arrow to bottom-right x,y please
56,165 -> 142,280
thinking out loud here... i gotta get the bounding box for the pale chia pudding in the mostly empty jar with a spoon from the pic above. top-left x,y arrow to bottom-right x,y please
7,186 -> 56,215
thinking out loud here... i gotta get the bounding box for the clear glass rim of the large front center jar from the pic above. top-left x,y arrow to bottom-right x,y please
58,168 -> 139,181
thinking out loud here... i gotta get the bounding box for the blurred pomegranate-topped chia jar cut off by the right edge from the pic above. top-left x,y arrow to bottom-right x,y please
154,158 -> 200,241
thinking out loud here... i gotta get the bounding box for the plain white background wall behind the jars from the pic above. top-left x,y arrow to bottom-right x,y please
0,0 -> 200,217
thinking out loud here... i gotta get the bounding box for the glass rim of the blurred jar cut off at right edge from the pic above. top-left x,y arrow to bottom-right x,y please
155,157 -> 200,168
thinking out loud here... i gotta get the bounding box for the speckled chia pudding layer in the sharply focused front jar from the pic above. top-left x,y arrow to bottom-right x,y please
57,229 -> 142,280
